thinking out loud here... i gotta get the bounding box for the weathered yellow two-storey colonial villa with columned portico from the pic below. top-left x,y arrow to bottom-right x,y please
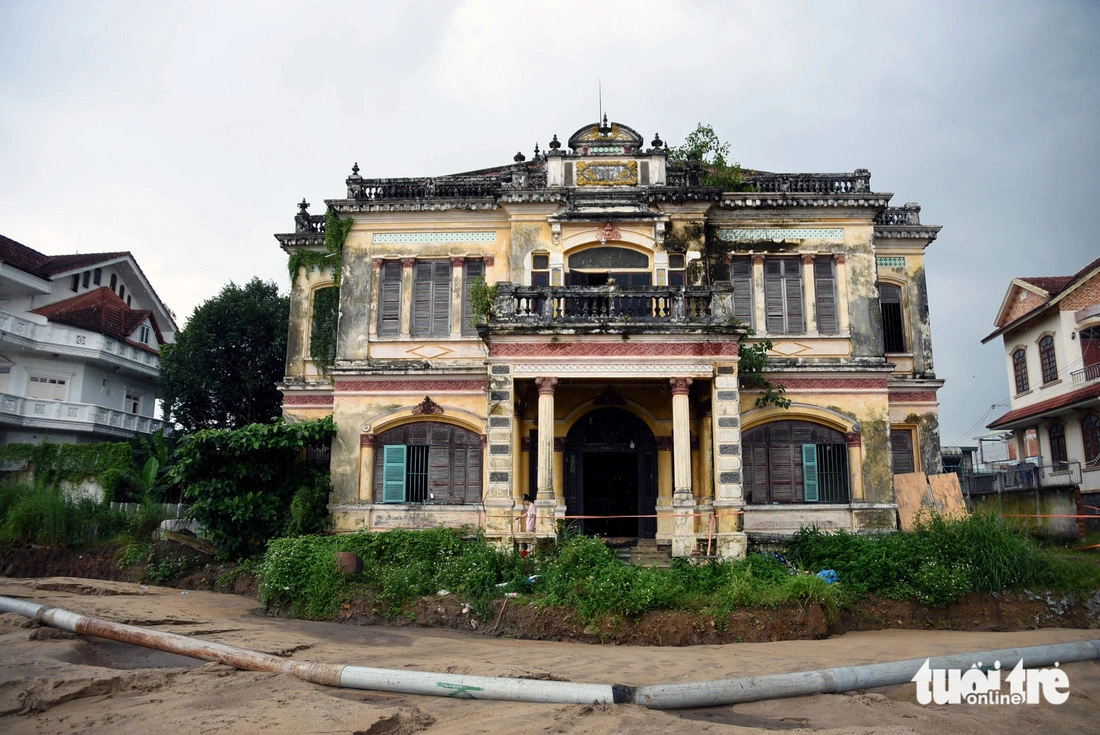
276,120 -> 943,557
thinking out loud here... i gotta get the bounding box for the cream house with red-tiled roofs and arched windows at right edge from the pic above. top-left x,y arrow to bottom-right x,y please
982,257 -> 1100,493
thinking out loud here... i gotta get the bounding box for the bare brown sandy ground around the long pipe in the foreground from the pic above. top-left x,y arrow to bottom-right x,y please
0,578 -> 1100,735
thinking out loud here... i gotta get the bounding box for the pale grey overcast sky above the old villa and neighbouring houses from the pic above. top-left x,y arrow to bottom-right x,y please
0,0 -> 1100,443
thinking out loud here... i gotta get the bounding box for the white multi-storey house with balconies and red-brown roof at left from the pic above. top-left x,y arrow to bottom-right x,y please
0,235 -> 176,443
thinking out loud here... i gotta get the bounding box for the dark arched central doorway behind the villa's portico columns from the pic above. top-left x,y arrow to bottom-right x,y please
564,408 -> 657,538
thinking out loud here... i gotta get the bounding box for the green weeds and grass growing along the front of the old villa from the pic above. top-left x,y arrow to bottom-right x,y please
260,514 -> 1100,624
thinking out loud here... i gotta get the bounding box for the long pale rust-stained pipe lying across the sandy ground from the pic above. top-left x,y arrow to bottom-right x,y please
0,596 -> 1100,710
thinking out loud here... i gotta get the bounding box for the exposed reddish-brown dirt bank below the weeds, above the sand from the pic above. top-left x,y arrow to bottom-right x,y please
0,546 -> 1100,646
